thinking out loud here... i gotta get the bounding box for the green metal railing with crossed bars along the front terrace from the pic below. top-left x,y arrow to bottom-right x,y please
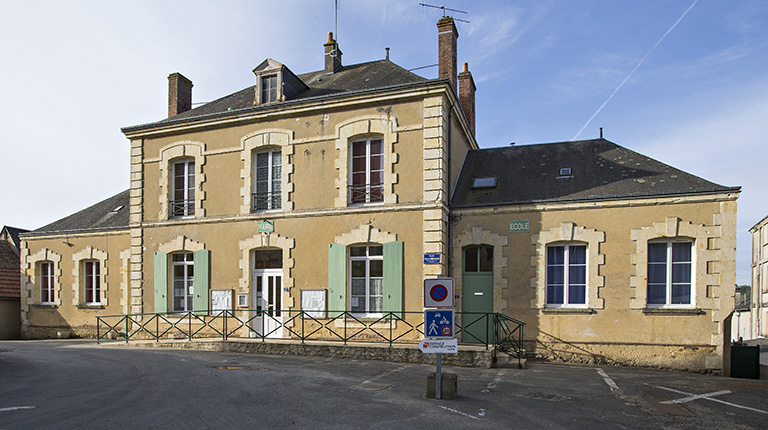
96,309 -> 525,360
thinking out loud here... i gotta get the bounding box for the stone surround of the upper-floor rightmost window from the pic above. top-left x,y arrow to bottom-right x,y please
335,115 -> 398,207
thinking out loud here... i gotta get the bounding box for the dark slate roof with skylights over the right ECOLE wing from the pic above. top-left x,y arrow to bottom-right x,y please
452,139 -> 740,208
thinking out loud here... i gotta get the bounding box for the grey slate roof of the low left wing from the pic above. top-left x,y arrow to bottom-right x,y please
22,190 -> 130,236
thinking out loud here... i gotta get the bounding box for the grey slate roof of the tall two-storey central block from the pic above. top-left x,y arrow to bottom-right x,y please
123,60 -> 428,131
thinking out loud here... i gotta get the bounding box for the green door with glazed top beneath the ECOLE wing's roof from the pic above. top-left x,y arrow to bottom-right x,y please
461,245 -> 493,343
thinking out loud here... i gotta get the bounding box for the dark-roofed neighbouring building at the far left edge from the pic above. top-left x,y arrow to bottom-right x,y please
0,226 -> 27,339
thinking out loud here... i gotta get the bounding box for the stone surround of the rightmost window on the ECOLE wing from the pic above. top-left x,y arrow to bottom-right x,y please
629,217 -> 720,310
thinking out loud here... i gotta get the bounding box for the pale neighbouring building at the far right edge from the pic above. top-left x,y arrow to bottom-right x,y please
745,217 -> 768,339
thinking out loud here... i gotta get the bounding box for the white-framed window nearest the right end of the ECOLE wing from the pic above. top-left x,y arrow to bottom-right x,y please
647,242 -> 693,307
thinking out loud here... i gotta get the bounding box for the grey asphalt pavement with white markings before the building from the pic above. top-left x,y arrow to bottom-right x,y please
0,340 -> 768,430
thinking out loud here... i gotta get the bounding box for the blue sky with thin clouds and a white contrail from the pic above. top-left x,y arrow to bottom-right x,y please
0,0 -> 768,284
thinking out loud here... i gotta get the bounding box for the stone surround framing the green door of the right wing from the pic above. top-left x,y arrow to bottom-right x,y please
452,226 -> 509,313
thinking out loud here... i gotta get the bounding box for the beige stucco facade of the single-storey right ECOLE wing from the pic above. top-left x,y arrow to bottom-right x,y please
453,194 -> 736,370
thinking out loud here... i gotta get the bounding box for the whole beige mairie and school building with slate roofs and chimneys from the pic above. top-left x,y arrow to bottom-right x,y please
16,18 -> 740,370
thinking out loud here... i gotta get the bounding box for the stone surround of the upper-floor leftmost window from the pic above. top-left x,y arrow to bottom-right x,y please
158,141 -> 205,220
